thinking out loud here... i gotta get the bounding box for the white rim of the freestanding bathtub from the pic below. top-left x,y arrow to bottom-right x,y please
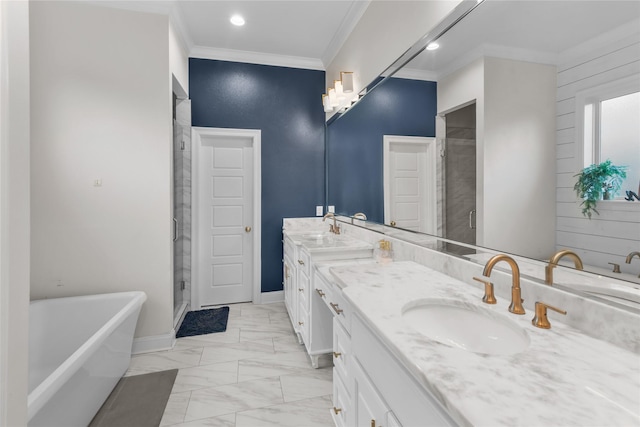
27,291 -> 147,420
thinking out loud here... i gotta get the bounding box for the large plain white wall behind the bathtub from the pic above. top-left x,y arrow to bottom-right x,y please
31,2 -> 173,337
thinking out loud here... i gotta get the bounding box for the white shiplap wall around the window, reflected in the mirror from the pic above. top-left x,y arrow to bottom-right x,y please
556,30 -> 640,274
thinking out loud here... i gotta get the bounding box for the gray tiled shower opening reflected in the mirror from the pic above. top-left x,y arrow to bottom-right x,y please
443,103 -> 476,255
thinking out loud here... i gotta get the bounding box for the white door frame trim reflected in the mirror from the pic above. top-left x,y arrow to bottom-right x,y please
382,135 -> 438,234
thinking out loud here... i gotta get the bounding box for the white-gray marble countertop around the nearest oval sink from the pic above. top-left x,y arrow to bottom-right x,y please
328,262 -> 640,426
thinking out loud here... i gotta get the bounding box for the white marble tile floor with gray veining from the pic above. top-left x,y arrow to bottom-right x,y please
125,303 -> 333,427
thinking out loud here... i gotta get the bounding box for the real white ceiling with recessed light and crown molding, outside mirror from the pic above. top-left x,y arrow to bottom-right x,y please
93,0 -> 369,69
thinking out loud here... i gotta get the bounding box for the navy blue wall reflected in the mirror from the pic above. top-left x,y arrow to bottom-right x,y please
327,78 -> 437,222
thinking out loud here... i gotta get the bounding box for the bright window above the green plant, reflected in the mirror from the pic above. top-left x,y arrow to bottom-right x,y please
583,91 -> 640,198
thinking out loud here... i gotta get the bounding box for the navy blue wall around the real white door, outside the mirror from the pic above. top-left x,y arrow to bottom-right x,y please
189,58 -> 325,292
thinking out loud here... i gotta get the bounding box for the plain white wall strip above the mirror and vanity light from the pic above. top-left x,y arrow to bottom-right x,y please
326,0 -> 460,112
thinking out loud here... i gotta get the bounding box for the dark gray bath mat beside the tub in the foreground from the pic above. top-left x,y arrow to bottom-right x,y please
89,369 -> 178,427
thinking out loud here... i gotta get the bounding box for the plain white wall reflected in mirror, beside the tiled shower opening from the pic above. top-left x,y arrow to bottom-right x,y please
438,58 -> 556,258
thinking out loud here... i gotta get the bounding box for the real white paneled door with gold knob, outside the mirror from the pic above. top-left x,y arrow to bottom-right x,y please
194,128 -> 259,307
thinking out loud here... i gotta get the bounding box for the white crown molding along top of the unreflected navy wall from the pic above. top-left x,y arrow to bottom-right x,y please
189,46 -> 325,71
